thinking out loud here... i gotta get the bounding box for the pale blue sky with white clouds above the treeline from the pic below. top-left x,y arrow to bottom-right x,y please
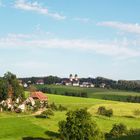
0,0 -> 140,80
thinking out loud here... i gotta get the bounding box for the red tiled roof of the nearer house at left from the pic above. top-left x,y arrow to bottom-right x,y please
31,91 -> 48,100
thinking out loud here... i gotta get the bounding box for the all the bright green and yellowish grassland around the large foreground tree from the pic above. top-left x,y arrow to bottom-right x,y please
0,94 -> 140,140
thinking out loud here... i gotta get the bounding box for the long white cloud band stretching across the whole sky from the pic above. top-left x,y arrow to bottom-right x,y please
0,34 -> 140,58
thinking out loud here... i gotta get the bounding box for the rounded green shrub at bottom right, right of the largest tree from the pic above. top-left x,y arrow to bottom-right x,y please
109,123 -> 127,138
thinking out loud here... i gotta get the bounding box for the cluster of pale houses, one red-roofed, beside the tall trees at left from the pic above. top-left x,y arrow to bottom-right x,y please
0,91 -> 48,112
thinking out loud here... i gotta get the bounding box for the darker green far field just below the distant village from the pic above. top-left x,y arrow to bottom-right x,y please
37,85 -> 140,101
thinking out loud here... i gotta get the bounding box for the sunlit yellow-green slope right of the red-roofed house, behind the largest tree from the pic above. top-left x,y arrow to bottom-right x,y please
48,95 -> 140,132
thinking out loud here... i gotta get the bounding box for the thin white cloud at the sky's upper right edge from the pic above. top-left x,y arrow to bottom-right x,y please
97,21 -> 140,34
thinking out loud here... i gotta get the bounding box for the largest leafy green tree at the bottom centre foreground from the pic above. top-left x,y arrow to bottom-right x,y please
59,109 -> 104,140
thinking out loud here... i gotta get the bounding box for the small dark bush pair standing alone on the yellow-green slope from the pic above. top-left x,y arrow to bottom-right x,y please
97,106 -> 113,117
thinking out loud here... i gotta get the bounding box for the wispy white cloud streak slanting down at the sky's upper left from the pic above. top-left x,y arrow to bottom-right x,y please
15,0 -> 66,20
